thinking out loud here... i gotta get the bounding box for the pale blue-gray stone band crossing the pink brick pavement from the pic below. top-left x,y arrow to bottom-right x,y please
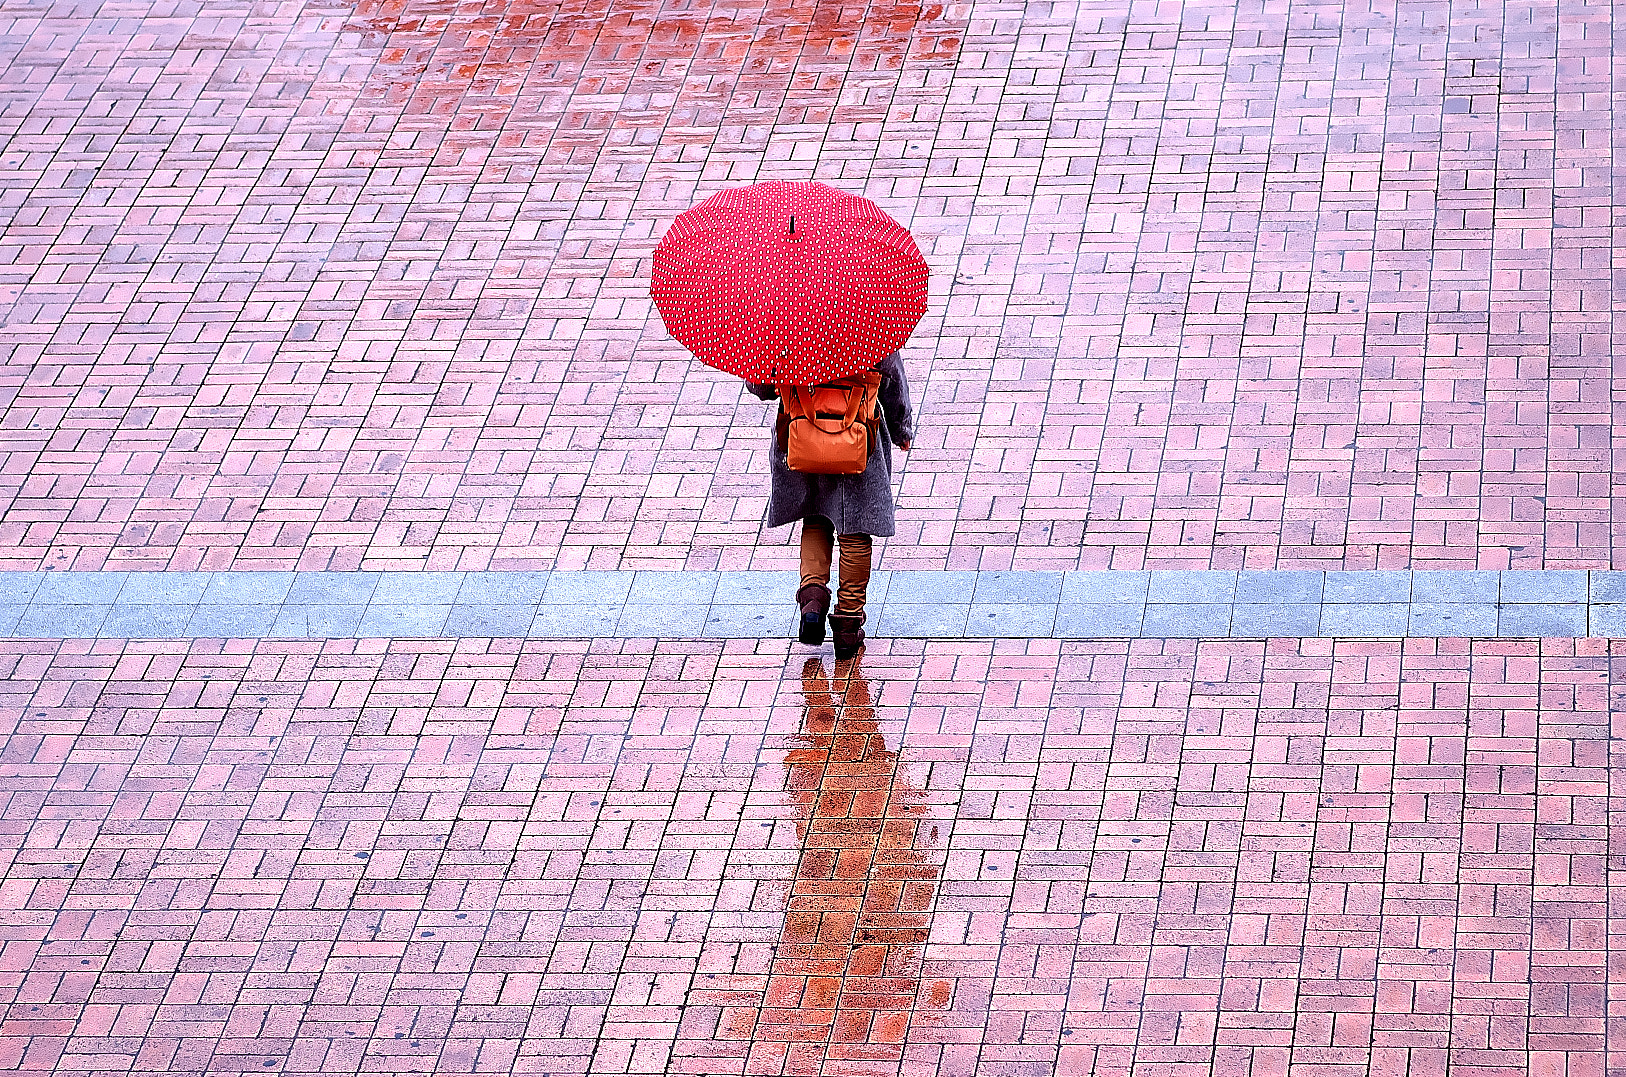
0,569 -> 1626,639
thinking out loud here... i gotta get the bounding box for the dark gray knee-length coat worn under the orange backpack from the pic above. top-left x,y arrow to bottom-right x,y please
746,351 -> 914,535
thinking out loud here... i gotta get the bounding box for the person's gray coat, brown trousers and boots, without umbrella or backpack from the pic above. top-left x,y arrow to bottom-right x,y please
746,351 -> 914,659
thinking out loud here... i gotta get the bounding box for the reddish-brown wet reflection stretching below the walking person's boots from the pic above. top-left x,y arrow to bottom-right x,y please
748,657 -> 946,1074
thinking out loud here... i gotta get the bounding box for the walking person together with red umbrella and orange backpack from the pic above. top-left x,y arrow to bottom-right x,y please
649,179 -> 930,659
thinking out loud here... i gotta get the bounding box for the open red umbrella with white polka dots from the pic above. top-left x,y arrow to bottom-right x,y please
649,181 -> 927,386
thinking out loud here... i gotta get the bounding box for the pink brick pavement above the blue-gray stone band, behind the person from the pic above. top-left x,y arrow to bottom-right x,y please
0,0 -> 1626,569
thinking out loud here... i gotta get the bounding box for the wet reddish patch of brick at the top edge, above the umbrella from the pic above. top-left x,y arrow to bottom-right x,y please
345,0 -> 966,152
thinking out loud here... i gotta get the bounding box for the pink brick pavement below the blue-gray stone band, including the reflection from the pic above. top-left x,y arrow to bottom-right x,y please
0,639 -> 1626,1077
